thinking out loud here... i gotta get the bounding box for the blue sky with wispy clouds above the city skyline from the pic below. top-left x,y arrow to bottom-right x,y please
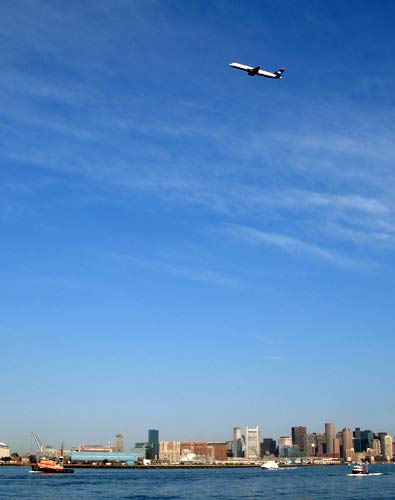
0,0 -> 395,451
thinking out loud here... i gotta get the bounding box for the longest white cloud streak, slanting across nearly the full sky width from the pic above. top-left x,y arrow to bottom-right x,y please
7,147 -> 391,216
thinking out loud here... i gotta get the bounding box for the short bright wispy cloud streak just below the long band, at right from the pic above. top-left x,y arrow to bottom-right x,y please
221,224 -> 368,268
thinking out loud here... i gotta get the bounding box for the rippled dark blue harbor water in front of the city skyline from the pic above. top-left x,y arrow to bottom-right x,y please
0,465 -> 395,500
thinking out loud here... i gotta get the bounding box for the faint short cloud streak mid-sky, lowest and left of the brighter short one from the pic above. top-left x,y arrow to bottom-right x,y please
112,254 -> 246,288
